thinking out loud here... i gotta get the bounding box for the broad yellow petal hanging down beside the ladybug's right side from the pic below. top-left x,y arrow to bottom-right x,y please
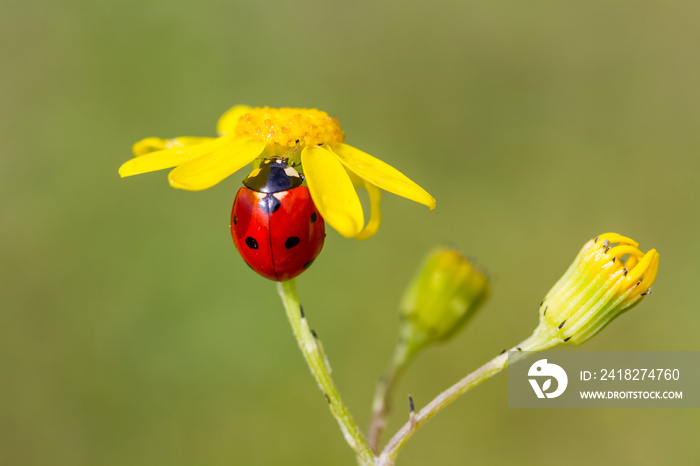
301,146 -> 365,238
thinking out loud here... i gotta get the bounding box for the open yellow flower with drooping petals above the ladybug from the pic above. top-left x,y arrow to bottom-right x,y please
119,105 -> 435,239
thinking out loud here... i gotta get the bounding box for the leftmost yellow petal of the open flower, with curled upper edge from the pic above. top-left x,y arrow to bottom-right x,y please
119,138 -> 228,178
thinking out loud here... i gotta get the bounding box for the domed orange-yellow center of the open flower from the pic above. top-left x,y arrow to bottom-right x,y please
234,107 -> 345,147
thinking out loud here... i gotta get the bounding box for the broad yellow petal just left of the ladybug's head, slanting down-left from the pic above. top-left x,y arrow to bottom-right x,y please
168,136 -> 265,191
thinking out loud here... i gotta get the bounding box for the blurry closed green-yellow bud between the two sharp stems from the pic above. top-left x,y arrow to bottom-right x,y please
401,247 -> 489,349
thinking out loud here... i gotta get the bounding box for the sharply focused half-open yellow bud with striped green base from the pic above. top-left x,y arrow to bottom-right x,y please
533,233 -> 659,345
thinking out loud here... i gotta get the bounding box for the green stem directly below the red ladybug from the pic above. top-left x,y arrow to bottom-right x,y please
277,280 -> 376,466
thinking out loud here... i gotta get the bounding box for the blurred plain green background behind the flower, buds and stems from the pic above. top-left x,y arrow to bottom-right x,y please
0,0 -> 700,466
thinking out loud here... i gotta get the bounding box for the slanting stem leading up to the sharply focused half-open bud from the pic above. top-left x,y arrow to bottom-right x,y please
377,331 -> 558,466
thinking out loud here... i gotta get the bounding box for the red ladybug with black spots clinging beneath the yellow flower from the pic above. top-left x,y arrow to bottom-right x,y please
231,158 -> 326,281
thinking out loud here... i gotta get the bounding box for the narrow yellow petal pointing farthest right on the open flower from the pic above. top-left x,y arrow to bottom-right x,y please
332,144 -> 435,209
